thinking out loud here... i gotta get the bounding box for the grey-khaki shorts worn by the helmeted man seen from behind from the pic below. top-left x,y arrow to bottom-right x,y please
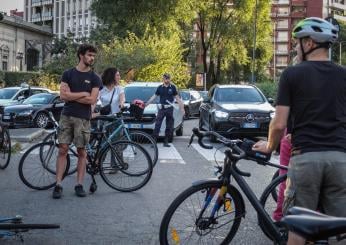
283,151 -> 346,217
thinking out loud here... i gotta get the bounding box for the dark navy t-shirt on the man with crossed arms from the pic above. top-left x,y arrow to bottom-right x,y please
61,68 -> 102,120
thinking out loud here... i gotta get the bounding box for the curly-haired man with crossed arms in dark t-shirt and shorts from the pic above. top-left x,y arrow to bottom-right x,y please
53,44 -> 101,199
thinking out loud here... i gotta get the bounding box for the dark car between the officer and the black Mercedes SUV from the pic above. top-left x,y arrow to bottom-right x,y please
180,89 -> 203,119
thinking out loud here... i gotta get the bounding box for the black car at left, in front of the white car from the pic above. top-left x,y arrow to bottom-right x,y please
1,93 -> 64,128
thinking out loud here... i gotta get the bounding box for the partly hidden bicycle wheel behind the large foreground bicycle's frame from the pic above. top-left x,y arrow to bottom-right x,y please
258,174 -> 287,240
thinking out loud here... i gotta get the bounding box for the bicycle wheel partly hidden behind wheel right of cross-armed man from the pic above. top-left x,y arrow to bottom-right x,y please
121,131 -> 159,167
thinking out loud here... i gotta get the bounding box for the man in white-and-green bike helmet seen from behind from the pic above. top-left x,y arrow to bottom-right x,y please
253,17 -> 346,245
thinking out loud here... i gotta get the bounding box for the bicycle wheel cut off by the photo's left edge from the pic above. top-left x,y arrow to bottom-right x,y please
0,121 -> 11,169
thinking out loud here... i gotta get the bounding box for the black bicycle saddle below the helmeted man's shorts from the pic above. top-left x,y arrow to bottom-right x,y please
281,211 -> 346,241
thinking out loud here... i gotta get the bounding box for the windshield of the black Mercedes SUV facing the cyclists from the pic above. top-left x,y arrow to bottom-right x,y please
215,88 -> 265,103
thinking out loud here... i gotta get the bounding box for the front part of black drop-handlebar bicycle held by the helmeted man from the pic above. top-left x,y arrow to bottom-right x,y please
160,128 -> 287,245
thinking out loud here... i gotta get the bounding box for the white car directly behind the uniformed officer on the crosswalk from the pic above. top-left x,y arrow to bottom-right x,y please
125,82 -> 183,139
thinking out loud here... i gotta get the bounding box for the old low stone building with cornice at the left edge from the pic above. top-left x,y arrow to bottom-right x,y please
0,16 -> 53,71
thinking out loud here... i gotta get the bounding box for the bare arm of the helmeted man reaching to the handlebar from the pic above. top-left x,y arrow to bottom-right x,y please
253,106 -> 290,153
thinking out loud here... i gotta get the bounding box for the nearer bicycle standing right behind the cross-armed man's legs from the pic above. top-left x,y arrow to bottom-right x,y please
18,116 -> 153,193
